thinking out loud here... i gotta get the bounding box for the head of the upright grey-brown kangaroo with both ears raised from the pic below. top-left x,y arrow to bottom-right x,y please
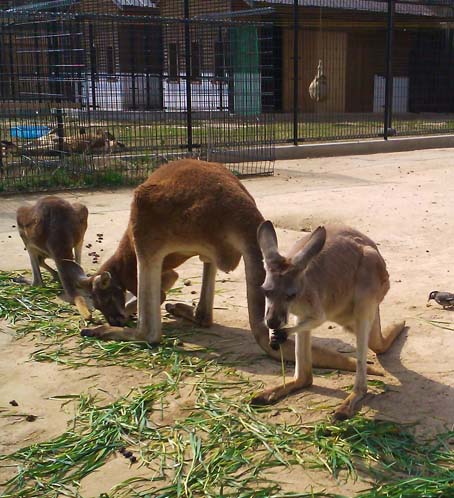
257,221 -> 326,330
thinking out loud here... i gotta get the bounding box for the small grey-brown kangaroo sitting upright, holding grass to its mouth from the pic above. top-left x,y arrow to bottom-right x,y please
253,221 -> 405,420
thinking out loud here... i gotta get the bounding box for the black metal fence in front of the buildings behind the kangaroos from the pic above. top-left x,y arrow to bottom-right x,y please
0,0 -> 454,192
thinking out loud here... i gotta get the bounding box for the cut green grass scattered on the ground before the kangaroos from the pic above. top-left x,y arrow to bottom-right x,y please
0,272 -> 454,498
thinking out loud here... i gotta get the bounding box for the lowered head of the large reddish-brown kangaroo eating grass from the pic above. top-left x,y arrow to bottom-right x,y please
60,260 -> 128,327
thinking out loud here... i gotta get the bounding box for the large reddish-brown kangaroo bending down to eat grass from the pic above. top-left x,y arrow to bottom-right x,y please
67,159 -> 384,371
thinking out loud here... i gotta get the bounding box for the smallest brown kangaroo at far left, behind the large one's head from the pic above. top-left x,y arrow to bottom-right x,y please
16,196 -> 91,319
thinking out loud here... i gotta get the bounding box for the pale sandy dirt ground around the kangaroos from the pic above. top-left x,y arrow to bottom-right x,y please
0,149 -> 454,497
